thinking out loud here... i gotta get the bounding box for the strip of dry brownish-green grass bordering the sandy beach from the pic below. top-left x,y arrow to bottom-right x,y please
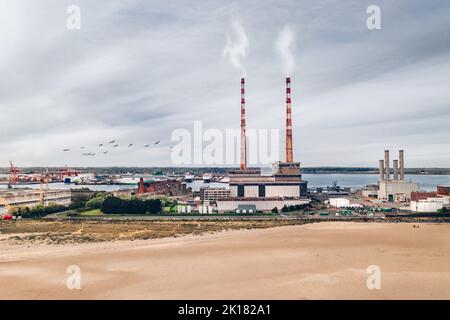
0,219 -> 307,246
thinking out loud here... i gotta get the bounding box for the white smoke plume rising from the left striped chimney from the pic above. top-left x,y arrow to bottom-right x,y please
223,20 -> 248,76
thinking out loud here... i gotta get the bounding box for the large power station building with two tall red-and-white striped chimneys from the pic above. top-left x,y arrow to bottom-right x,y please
217,78 -> 309,212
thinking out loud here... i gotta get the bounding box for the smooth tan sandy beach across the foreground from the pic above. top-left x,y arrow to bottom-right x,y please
0,222 -> 450,299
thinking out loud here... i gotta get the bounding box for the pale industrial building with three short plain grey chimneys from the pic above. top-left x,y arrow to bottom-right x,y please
378,150 -> 419,202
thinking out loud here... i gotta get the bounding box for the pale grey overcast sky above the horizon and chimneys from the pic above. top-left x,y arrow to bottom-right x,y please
0,0 -> 450,167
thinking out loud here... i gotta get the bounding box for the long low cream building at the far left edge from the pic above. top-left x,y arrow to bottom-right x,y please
0,188 -> 72,213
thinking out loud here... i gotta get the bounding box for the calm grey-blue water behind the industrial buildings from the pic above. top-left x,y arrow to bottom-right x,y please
0,174 -> 450,191
